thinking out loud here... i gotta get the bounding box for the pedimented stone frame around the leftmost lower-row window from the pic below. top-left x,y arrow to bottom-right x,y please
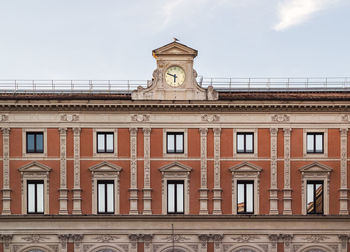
18,162 -> 51,214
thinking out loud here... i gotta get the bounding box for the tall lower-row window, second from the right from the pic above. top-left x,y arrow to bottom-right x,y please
237,181 -> 254,214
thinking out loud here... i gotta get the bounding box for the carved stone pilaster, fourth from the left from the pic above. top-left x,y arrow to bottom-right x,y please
129,128 -> 138,214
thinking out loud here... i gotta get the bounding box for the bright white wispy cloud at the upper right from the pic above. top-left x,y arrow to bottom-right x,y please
273,0 -> 341,31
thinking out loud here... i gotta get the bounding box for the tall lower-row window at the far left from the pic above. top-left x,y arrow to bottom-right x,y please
27,180 -> 44,213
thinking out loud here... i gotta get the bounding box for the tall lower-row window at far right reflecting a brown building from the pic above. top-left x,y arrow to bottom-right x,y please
306,181 -> 323,214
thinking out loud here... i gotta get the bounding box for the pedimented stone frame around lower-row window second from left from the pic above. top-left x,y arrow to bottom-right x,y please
89,161 -> 123,214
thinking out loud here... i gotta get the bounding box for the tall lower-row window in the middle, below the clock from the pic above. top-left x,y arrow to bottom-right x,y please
168,180 -> 184,214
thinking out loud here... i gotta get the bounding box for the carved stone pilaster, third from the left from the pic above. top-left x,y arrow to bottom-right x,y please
73,128 -> 81,214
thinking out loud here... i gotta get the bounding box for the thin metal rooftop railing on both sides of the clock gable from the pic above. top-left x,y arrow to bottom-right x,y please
0,76 -> 350,93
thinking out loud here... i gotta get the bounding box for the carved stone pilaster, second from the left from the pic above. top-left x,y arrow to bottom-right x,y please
58,128 -> 68,214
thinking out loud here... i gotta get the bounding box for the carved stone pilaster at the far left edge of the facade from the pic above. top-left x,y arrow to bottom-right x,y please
1,128 -> 11,215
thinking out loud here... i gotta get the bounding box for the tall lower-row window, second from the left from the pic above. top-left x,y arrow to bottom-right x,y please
97,180 -> 114,214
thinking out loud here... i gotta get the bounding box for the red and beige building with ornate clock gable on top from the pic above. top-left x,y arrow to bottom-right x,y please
0,42 -> 350,252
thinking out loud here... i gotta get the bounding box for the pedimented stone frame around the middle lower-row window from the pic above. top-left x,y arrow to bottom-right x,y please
159,162 -> 192,214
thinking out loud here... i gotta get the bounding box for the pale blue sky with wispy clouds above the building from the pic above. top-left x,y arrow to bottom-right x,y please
0,0 -> 350,80
